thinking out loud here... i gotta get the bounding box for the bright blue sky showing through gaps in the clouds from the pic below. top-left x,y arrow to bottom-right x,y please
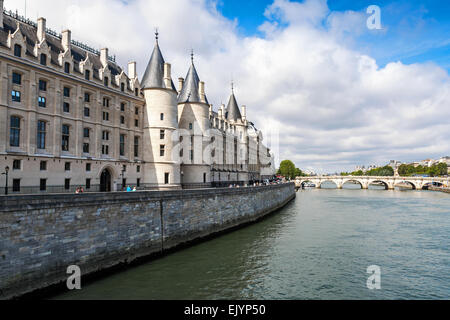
217,0 -> 450,71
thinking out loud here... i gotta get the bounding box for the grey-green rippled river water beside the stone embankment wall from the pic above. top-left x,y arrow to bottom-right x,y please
54,185 -> 450,300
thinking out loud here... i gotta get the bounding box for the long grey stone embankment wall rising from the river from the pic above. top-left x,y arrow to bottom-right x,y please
0,184 -> 295,299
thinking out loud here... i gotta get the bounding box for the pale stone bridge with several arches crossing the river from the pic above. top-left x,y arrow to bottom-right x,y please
295,176 -> 450,190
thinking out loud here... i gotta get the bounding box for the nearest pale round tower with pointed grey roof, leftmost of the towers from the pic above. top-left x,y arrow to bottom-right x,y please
141,33 -> 181,190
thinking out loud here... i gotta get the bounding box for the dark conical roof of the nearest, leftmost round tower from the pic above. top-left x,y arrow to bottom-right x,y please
141,32 -> 176,91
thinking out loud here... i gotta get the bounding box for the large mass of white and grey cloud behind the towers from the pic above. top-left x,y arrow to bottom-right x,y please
17,0 -> 450,172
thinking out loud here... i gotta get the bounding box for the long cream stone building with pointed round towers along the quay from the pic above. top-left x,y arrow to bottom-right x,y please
0,0 -> 275,194
